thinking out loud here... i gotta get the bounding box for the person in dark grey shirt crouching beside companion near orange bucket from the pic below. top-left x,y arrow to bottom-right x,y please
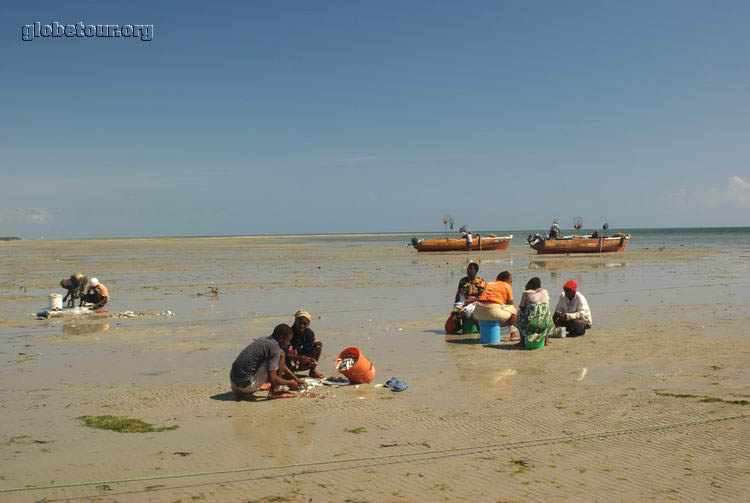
229,323 -> 305,399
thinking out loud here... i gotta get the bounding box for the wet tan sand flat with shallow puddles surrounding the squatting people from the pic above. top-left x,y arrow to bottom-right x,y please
0,237 -> 750,502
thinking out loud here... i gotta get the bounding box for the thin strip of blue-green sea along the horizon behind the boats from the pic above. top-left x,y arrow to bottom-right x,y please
274,227 -> 750,250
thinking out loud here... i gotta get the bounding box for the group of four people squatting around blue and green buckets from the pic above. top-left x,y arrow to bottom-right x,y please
446,262 -> 591,345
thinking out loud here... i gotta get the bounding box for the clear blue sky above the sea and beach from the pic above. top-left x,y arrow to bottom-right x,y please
0,0 -> 750,239
